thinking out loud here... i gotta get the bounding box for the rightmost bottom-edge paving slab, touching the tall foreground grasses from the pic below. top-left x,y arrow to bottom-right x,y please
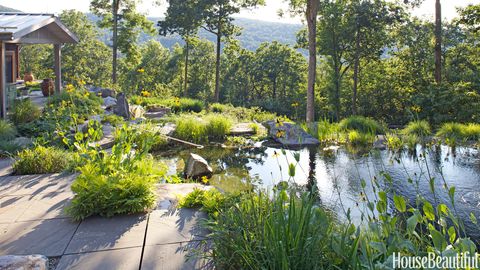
141,241 -> 205,270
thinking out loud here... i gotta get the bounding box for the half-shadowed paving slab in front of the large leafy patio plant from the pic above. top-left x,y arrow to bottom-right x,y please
65,215 -> 147,254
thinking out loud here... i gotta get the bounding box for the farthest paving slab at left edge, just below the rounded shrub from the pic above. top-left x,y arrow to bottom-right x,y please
0,174 -> 77,197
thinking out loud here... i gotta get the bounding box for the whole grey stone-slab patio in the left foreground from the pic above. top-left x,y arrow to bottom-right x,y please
0,172 -> 210,270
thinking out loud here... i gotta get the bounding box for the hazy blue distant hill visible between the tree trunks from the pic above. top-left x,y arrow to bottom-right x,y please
87,14 -> 302,51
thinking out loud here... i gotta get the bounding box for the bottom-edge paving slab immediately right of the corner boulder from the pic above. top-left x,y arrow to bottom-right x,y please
56,247 -> 142,270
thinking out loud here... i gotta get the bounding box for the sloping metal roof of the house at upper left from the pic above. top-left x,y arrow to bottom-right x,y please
0,12 -> 78,44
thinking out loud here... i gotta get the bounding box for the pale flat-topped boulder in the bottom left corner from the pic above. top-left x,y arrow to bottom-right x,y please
0,255 -> 48,270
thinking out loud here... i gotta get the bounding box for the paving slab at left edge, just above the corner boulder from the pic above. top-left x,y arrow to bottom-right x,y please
0,219 -> 78,257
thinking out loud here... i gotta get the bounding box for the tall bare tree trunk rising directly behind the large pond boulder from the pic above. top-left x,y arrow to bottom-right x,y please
306,0 -> 318,123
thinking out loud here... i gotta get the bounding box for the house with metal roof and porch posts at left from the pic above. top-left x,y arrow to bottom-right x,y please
0,12 -> 78,118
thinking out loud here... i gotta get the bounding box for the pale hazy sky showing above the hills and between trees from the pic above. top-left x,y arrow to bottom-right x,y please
0,0 -> 480,23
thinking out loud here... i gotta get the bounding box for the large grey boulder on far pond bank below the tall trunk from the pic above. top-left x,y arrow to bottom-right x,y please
265,121 -> 320,147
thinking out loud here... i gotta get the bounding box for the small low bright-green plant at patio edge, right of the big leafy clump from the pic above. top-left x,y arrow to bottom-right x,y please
178,188 -> 225,217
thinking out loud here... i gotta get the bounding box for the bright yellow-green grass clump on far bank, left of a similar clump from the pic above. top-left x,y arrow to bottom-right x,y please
175,116 -> 208,143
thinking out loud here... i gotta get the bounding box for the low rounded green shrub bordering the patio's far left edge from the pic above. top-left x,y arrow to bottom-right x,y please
13,146 -> 72,175
